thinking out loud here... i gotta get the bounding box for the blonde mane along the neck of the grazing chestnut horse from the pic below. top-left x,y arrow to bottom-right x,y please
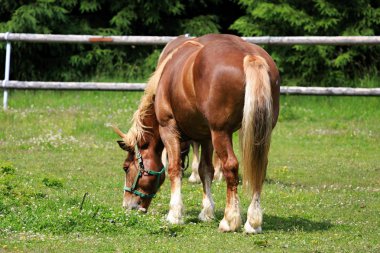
123,40 -> 203,147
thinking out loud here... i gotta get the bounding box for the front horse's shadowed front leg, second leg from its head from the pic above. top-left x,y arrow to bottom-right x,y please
198,141 -> 215,221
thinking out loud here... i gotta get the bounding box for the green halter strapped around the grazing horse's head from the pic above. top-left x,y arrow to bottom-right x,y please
124,144 -> 165,199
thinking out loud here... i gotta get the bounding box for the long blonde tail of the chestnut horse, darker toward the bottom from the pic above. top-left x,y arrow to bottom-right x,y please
240,55 -> 273,194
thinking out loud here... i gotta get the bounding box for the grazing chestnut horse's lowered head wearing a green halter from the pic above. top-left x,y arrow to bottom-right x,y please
114,128 -> 165,212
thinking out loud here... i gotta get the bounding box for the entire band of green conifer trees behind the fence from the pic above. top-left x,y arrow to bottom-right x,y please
0,0 -> 380,87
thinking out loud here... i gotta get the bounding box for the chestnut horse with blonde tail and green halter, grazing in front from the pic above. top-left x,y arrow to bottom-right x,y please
115,35 -> 280,233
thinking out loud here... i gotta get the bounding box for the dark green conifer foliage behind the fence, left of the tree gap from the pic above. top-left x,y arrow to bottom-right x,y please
0,0 -> 237,81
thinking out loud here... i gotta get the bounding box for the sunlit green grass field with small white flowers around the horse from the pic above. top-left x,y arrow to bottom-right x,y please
0,91 -> 380,252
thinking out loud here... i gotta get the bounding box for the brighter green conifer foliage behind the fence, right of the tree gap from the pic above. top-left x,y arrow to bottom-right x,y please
231,0 -> 380,86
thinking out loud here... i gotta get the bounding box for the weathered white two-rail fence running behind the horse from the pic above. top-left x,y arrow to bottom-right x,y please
0,33 -> 380,109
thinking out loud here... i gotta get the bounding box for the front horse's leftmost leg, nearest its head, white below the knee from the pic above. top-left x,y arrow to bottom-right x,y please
159,122 -> 183,224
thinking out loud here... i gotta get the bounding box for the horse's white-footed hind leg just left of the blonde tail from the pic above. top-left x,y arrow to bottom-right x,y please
212,131 -> 242,232
